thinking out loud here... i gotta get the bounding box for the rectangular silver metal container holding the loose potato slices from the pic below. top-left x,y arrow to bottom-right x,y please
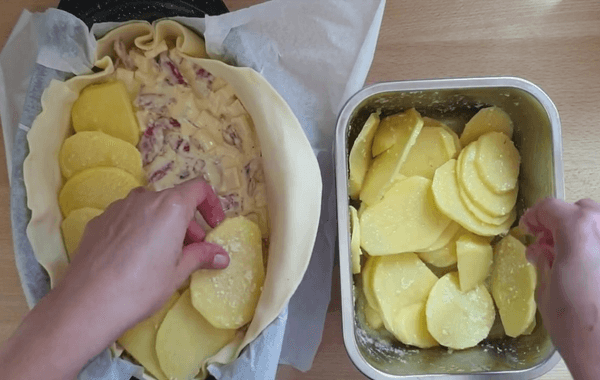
334,77 -> 564,379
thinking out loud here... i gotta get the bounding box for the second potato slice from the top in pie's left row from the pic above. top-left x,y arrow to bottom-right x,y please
59,132 -> 145,182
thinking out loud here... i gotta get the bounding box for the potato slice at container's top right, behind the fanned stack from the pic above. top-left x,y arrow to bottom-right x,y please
460,107 -> 513,147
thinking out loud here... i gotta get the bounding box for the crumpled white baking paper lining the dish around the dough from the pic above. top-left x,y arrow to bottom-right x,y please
0,0 -> 385,379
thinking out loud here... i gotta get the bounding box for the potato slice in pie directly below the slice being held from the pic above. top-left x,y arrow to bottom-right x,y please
156,289 -> 236,380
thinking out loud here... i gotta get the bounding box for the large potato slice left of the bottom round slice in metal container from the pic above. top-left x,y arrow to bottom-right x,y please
372,253 -> 438,331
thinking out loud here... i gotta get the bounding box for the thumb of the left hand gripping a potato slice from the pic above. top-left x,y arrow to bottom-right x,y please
176,241 -> 229,284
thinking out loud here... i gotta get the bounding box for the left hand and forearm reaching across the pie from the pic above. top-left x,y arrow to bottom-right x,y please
0,180 -> 229,380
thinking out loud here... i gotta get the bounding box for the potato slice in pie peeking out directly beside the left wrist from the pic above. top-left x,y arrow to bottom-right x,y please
117,293 -> 179,380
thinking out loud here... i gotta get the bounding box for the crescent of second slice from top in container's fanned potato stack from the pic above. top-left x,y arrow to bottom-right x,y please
456,142 -> 518,217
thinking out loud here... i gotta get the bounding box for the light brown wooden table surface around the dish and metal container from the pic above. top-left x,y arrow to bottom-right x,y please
0,0 -> 600,380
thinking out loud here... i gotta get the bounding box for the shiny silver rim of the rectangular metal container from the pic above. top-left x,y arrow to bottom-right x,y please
334,76 -> 565,380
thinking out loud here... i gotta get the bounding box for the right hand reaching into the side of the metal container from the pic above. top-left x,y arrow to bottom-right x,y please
520,198 -> 600,379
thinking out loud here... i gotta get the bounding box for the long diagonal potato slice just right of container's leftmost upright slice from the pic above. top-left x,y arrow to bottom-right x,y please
360,110 -> 423,206
